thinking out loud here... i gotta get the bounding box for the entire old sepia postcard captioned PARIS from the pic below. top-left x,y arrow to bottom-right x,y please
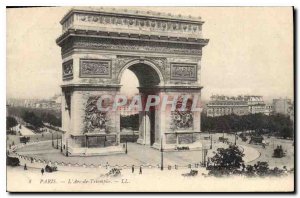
6,7 -> 295,192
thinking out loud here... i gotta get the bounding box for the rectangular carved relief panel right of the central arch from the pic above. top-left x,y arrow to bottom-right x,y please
171,63 -> 197,81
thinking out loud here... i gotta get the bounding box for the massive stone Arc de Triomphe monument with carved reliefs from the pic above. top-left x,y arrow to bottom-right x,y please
56,8 -> 208,155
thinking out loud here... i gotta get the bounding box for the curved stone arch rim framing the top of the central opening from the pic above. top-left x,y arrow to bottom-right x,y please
117,59 -> 165,86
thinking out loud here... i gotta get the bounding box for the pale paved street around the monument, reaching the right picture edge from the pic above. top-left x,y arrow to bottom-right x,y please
12,134 -> 294,168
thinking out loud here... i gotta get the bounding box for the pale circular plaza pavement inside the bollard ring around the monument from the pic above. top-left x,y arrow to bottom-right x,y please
17,138 -> 260,167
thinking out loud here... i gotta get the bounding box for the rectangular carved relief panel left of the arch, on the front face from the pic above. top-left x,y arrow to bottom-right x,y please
80,59 -> 111,78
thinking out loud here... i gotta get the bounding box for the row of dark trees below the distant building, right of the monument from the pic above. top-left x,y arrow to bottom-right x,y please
201,113 -> 294,138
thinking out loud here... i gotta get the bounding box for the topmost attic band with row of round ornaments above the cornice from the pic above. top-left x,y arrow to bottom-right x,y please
63,11 -> 203,34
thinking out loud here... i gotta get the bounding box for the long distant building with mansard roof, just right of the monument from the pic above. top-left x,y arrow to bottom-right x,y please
206,95 -> 270,117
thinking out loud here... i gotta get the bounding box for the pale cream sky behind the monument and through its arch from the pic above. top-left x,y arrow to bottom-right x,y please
6,7 -> 294,100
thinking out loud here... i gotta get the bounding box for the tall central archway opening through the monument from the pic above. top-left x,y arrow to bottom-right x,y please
120,62 -> 162,146
